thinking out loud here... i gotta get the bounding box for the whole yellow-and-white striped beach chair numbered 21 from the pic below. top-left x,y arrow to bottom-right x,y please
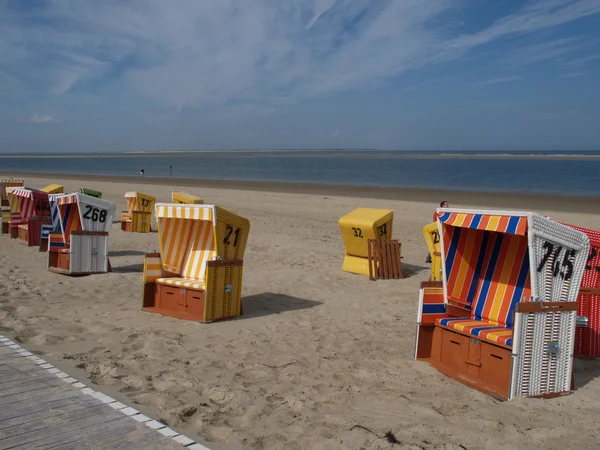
142,203 -> 250,322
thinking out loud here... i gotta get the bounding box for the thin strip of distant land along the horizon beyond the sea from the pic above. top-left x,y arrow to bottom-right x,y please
0,150 -> 600,161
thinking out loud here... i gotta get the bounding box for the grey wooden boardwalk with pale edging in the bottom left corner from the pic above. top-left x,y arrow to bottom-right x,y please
0,336 -> 208,450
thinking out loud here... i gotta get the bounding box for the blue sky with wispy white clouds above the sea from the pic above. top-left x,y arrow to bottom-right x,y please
0,0 -> 600,153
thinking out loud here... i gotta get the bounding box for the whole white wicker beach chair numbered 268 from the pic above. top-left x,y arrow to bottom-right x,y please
48,192 -> 117,275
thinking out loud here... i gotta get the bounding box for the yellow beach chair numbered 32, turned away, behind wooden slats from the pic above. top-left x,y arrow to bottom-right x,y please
339,208 -> 394,275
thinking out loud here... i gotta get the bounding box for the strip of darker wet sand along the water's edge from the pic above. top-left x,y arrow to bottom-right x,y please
0,172 -> 599,213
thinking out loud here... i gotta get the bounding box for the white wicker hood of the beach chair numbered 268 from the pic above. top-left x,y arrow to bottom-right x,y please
56,192 -> 117,242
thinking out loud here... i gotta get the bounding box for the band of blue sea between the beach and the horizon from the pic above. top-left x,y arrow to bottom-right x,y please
0,149 -> 600,198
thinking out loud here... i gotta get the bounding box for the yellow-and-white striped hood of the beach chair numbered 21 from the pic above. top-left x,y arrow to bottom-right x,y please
156,203 -> 250,282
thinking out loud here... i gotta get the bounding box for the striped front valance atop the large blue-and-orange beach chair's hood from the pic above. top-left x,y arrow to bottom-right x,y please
438,211 -> 527,236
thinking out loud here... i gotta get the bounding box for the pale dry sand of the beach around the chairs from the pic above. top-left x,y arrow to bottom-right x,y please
0,176 -> 600,450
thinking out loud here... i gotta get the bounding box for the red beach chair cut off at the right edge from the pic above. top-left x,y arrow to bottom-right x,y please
563,223 -> 600,358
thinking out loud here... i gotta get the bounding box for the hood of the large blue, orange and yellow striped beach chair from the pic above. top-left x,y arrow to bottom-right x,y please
438,209 -> 589,332
